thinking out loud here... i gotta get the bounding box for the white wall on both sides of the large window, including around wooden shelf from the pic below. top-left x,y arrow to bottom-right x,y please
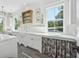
11,0 -> 76,35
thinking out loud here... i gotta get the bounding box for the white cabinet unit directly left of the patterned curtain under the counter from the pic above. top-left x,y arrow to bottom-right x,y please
23,34 -> 42,52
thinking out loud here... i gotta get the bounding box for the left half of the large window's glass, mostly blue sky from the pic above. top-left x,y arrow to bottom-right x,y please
47,8 -> 55,32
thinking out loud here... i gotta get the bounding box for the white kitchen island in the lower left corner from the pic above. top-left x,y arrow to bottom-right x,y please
0,35 -> 18,58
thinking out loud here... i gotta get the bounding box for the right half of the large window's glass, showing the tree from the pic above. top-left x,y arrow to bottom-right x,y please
55,6 -> 63,32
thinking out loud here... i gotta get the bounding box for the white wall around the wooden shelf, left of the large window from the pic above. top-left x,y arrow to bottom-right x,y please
12,0 -> 65,33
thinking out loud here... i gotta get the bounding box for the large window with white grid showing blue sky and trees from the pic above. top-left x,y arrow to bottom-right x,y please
47,5 -> 64,32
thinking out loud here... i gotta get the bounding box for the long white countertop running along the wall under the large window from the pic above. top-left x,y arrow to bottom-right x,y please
3,32 -> 79,40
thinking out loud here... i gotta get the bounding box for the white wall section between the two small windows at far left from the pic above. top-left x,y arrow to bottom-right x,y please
4,13 -> 13,31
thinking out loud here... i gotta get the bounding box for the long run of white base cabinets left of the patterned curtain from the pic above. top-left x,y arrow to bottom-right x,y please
4,32 -> 42,52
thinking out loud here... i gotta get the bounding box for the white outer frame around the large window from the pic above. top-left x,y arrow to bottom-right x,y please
46,2 -> 65,34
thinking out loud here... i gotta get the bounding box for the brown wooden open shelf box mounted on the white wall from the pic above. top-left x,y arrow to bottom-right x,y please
22,10 -> 33,24
